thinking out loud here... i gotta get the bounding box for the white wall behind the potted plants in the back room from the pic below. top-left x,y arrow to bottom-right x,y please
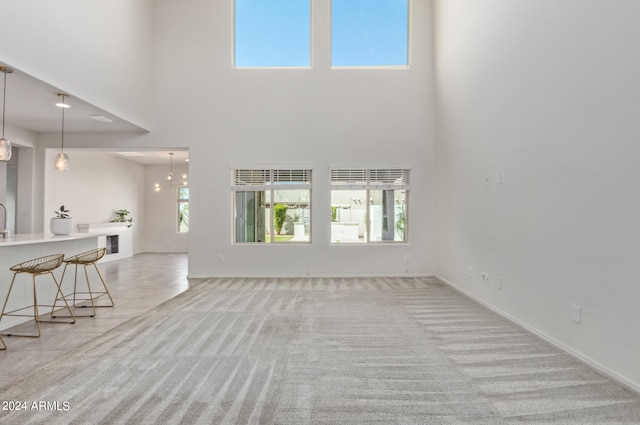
44,149 -> 149,254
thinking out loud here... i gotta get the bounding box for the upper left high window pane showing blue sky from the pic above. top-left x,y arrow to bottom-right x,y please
235,0 -> 311,67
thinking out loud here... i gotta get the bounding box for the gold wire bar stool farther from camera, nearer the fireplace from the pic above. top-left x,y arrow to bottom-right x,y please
56,248 -> 114,317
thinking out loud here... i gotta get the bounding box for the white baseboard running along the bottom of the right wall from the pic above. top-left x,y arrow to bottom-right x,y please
435,275 -> 640,393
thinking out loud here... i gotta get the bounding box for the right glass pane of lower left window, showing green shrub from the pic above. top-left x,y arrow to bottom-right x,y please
273,189 -> 311,242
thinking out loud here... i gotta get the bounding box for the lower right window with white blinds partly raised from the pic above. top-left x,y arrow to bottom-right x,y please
331,168 -> 409,243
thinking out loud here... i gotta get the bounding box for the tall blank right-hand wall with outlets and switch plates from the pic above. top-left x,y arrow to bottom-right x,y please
435,0 -> 640,389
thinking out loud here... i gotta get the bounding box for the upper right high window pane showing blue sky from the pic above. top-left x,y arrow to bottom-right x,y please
331,0 -> 409,66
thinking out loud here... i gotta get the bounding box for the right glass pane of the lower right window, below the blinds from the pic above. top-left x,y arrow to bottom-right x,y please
369,190 -> 406,242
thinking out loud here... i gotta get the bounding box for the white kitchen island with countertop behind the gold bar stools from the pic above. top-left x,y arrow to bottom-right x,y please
0,233 -> 102,331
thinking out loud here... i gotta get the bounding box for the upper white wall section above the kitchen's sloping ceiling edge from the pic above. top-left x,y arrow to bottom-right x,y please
0,0 -> 153,128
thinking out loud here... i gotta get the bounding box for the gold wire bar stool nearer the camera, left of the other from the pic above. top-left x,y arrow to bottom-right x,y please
0,254 -> 76,338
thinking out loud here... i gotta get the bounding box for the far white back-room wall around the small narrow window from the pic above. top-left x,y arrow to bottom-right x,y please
144,164 -> 189,252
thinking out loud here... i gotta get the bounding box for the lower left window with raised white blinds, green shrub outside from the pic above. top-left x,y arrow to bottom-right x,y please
231,169 -> 311,243
